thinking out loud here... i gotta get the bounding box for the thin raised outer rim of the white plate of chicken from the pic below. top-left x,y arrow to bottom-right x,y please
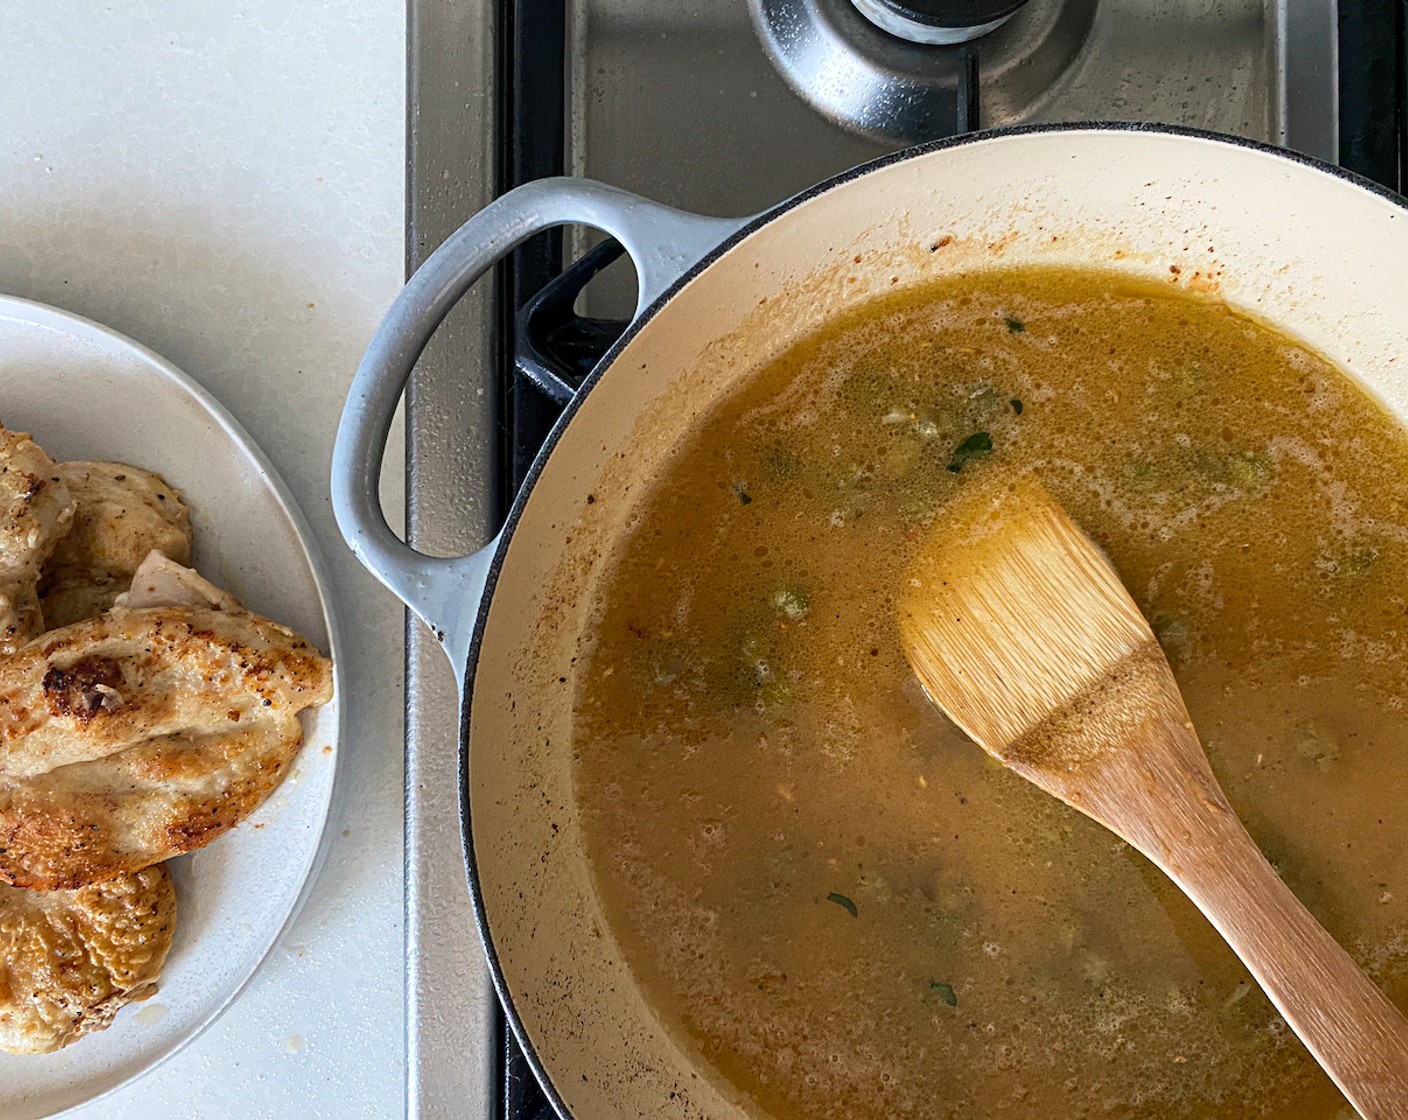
0,292 -> 345,1120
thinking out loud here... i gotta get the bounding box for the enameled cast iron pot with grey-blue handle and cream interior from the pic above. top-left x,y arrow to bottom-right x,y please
332,125 -> 1408,1120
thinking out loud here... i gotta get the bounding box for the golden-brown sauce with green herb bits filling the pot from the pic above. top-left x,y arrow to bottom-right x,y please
574,270 -> 1408,1120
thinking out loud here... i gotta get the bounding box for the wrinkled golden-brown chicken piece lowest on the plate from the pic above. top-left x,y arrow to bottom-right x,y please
0,866 -> 176,1054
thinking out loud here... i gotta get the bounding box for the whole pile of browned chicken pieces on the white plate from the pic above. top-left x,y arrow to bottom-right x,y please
0,427 -> 332,1054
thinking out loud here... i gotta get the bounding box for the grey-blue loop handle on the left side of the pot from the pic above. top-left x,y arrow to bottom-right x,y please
332,178 -> 745,683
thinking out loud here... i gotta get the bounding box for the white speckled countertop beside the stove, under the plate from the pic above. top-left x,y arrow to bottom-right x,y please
0,0 -> 411,1120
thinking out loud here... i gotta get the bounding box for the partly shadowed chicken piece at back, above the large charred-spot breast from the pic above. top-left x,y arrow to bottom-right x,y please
39,459 -> 191,628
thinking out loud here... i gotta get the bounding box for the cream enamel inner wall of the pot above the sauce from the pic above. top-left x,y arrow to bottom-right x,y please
470,130 -> 1408,1120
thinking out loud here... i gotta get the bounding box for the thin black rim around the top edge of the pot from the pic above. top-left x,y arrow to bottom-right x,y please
459,121 -> 1408,1120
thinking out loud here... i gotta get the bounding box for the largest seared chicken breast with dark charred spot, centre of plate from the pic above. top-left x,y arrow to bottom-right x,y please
0,594 -> 332,890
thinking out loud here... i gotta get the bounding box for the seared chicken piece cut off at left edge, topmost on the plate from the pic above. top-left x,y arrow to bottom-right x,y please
0,427 -> 75,654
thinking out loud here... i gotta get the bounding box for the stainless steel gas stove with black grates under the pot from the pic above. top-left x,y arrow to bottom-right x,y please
406,0 -> 1408,1120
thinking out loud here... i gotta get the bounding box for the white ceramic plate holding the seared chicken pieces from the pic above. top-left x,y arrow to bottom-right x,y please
0,296 -> 342,1120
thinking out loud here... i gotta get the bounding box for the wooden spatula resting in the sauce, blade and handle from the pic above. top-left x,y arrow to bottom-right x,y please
900,485 -> 1408,1120
